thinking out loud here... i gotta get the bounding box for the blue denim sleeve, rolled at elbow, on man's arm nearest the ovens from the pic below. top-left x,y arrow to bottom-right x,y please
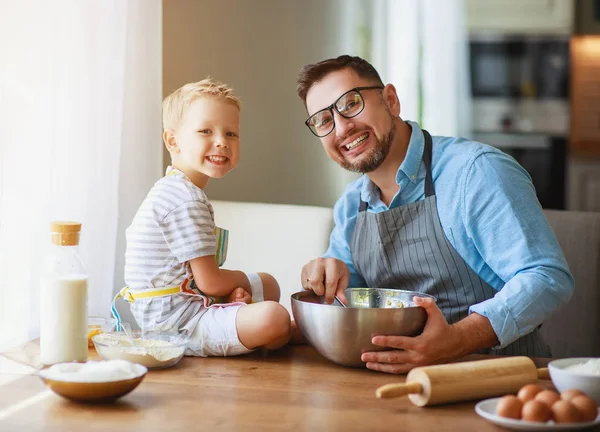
461,152 -> 574,347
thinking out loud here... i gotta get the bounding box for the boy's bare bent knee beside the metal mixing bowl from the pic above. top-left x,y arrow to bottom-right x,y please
235,301 -> 291,350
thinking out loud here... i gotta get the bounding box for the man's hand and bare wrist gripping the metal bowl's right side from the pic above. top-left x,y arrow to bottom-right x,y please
361,297 -> 498,374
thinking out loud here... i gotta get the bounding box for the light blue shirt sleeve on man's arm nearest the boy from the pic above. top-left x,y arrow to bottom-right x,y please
323,193 -> 367,288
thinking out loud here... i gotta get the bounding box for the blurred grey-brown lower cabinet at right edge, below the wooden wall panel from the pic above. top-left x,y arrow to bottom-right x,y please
567,158 -> 600,212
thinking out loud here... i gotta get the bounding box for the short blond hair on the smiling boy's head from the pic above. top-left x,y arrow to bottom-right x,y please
162,77 -> 241,130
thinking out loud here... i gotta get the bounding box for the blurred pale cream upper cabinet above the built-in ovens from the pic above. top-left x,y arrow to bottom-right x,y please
467,0 -> 574,34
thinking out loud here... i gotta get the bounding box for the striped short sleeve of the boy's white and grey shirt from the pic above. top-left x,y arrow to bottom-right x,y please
160,201 -> 217,263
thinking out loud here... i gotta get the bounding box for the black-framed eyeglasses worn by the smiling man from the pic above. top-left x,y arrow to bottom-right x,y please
304,86 -> 383,138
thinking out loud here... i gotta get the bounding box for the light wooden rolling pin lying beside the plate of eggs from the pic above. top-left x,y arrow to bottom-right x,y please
375,357 -> 550,406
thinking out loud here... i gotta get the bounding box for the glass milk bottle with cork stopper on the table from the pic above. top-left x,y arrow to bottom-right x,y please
40,222 -> 88,366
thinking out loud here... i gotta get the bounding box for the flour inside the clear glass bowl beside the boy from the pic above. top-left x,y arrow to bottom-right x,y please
95,336 -> 185,368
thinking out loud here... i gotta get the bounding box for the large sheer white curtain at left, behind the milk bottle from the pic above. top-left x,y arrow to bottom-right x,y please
0,0 -> 162,351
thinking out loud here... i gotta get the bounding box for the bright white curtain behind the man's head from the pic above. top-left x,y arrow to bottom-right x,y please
368,0 -> 471,136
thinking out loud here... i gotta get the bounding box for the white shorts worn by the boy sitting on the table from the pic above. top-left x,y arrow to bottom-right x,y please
185,273 -> 264,357
